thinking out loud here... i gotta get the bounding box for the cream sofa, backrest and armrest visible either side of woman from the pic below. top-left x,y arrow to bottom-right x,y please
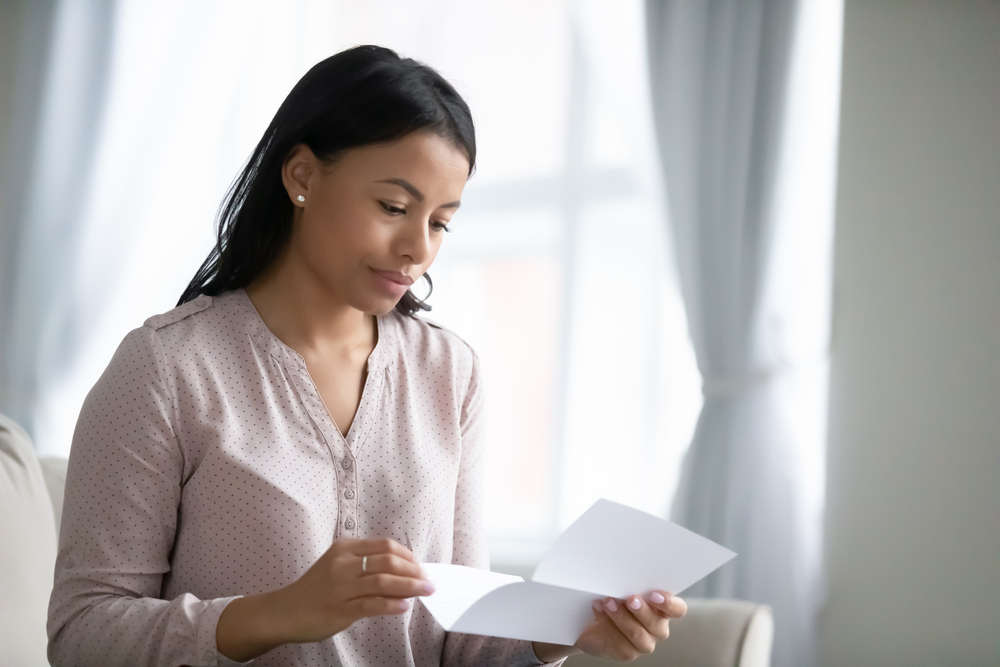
0,415 -> 774,667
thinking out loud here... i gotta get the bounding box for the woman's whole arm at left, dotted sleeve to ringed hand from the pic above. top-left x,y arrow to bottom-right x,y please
49,328 -> 428,667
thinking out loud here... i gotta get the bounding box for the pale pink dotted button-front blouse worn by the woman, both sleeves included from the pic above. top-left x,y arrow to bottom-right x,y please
48,290 -> 556,667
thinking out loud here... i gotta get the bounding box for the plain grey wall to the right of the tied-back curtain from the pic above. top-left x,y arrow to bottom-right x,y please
821,0 -> 1000,667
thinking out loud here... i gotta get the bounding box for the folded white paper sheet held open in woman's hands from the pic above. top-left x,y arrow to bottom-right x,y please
421,499 -> 736,644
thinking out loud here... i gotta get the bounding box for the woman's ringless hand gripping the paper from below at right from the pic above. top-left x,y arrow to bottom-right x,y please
534,591 -> 687,662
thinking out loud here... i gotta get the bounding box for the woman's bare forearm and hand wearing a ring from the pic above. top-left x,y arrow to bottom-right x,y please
215,539 -> 434,662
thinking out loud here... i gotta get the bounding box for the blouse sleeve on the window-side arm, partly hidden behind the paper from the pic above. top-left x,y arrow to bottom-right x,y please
442,356 -> 563,667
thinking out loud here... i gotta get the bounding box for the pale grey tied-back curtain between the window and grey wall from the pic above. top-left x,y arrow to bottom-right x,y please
646,0 -> 842,667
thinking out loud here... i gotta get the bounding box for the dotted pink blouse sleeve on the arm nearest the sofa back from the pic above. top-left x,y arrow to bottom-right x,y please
48,327 -> 244,667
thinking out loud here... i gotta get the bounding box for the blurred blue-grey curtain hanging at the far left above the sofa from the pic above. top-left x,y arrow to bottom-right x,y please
0,0 -> 115,451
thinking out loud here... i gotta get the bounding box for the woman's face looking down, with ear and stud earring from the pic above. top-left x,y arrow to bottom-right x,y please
282,131 -> 469,315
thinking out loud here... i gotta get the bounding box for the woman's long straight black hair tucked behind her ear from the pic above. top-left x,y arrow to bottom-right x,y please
177,46 -> 476,315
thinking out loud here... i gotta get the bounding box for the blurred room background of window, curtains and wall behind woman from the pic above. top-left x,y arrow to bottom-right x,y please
0,0 -> 1000,667
